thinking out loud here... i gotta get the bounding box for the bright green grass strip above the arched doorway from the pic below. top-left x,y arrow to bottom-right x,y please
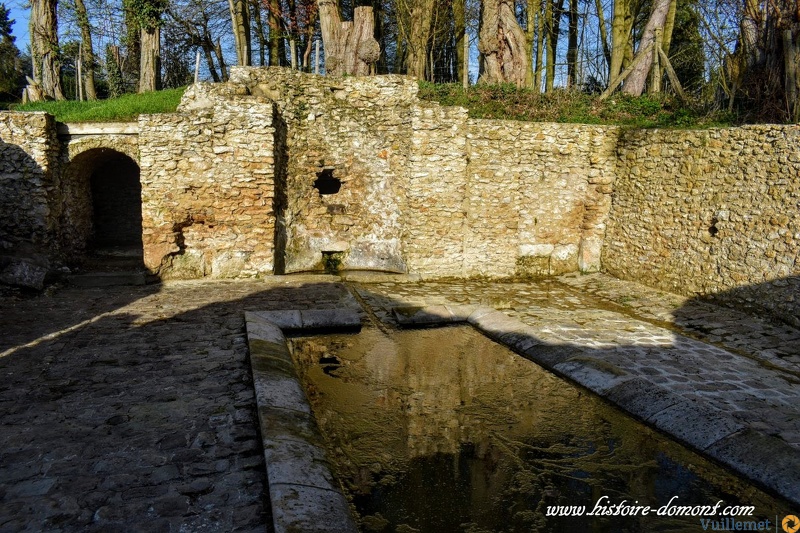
13,87 -> 186,122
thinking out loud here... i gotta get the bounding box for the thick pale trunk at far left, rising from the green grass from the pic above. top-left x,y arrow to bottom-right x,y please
30,0 -> 65,100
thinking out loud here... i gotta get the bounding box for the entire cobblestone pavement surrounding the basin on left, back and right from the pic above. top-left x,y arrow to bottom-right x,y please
0,275 -> 800,531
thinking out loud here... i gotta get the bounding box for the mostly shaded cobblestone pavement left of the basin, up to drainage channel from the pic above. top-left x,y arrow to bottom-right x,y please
0,282 -> 351,532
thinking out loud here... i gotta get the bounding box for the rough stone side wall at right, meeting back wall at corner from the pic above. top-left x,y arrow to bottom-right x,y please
603,125 -> 800,325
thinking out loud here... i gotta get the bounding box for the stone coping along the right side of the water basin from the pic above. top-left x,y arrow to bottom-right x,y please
392,304 -> 800,504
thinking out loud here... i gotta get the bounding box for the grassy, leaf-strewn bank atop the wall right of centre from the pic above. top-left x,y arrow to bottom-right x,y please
419,82 -> 735,128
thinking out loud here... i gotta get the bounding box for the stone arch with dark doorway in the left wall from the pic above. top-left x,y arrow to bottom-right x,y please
60,143 -> 142,264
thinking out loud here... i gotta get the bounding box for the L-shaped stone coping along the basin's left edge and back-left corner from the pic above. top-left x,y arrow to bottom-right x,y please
245,309 -> 361,533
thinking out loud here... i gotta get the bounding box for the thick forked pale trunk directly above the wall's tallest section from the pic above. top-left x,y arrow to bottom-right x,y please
319,0 -> 378,76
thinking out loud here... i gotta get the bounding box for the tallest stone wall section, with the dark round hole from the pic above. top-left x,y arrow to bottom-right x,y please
222,68 -> 418,272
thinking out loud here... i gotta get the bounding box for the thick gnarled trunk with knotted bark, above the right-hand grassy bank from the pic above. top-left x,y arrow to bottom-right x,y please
478,0 -> 530,87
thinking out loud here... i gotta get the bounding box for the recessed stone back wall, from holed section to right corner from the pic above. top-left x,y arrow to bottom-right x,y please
222,68 -> 616,277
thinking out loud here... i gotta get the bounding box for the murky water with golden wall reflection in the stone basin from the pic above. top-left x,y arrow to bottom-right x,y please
293,327 -> 788,533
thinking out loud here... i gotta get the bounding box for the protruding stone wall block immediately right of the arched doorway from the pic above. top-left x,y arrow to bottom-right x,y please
139,85 -> 276,278
